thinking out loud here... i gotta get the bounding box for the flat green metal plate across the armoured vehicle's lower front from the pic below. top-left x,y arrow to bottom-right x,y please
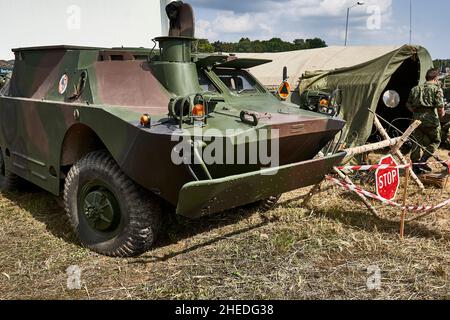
177,153 -> 345,218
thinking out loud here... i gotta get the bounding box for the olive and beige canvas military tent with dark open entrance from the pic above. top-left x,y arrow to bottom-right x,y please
238,45 -> 433,146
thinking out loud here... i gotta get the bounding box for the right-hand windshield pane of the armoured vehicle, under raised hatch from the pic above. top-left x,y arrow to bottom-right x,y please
214,69 -> 263,94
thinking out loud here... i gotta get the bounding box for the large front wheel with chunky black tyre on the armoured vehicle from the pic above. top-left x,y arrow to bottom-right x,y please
64,152 -> 162,257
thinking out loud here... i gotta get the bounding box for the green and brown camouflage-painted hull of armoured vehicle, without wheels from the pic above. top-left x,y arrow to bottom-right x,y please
0,38 -> 345,217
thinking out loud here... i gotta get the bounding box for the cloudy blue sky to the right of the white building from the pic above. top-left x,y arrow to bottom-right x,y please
190,0 -> 450,58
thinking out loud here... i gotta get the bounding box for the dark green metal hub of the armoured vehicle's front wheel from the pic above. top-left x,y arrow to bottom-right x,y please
83,188 -> 120,232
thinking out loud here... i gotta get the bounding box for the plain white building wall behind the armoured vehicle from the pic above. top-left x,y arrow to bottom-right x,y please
0,0 -> 170,59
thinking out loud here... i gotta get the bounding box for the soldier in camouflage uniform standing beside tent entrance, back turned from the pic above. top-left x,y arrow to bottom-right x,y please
407,69 -> 445,174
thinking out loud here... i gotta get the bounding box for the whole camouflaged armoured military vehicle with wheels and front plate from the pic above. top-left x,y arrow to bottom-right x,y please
0,2 -> 345,257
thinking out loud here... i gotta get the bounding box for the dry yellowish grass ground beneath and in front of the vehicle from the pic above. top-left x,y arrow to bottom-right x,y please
0,152 -> 450,299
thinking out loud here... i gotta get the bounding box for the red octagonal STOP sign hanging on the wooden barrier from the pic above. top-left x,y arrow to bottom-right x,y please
376,155 -> 400,200
